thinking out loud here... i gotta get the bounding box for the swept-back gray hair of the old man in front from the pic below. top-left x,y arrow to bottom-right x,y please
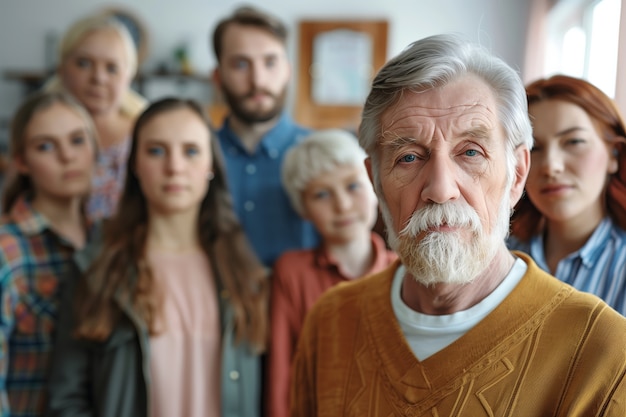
359,34 -> 533,188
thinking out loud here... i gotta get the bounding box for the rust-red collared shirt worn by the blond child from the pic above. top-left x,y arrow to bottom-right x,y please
267,233 -> 397,417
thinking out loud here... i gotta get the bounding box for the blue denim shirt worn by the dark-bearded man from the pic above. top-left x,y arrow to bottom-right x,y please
217,114 -> 320,268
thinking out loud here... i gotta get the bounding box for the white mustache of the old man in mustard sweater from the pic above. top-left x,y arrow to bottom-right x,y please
399,201 -> 482,237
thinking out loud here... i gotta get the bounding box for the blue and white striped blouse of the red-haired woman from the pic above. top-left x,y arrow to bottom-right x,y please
508,217 -> 626,315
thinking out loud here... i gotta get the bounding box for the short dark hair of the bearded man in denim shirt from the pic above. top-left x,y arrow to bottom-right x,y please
213,6 -> 287,62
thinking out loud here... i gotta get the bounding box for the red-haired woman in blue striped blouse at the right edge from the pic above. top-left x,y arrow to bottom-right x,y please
509,75 -> 626,314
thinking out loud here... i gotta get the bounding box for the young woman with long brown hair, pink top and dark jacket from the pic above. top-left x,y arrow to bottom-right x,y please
45,99 -> 267,417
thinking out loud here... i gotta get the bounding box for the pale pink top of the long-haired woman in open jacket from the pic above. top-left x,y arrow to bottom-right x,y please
149,251 -> 221,417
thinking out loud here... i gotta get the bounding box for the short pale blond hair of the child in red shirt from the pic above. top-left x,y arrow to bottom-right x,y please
281,129 -> 369,216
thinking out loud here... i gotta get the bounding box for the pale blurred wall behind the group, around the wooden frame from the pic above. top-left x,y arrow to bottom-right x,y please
0,0 -> 529,136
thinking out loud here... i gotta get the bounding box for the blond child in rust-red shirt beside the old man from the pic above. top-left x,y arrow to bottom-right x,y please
268,129 -> 396,417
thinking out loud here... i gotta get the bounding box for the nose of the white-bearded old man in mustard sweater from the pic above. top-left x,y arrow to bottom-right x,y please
420,153 -> 461,204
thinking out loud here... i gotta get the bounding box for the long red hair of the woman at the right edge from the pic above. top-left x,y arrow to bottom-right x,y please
511,75 -> 626,241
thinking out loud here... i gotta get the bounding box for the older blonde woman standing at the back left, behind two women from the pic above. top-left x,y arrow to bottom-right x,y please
46,15 -> 146,219
